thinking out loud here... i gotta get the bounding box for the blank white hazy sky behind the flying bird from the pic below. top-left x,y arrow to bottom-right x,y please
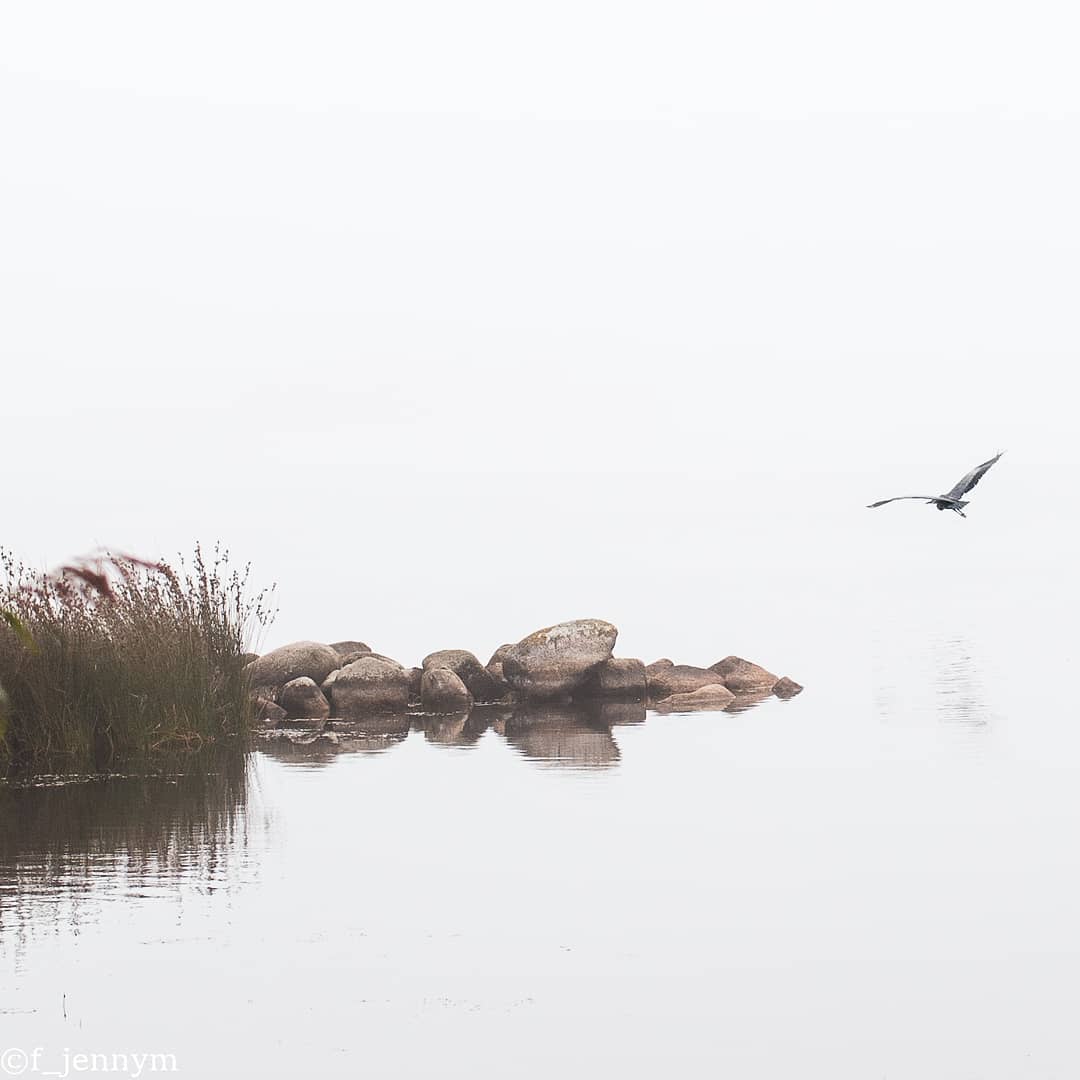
0,0 -> 1080,675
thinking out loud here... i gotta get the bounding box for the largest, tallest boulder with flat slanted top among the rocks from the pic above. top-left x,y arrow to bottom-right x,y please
502,619 -> 619,700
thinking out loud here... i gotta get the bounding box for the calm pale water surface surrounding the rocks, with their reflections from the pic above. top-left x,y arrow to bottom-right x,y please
0,534 -> 1080,1080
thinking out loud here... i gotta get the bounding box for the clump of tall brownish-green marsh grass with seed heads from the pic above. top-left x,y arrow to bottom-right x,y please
0,546 -> 271,770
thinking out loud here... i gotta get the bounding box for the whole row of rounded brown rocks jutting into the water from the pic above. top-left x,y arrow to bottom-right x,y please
244,619 -> 802,723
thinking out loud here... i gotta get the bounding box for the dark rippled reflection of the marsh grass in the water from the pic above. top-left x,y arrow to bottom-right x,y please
0,751 -> 249,954
